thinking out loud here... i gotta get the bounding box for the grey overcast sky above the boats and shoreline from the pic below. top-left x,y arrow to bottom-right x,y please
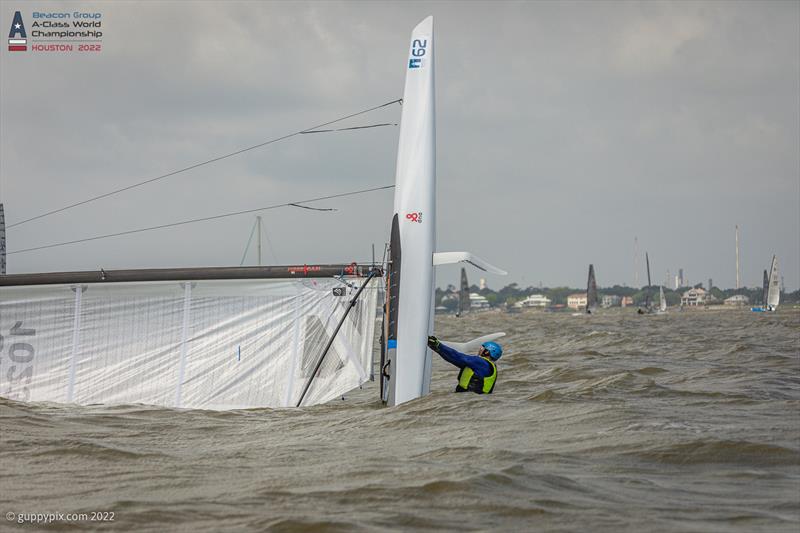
0,0 -> 800,290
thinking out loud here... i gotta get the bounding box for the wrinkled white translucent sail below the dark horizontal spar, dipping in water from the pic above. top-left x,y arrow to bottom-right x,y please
0,278 -> 378,409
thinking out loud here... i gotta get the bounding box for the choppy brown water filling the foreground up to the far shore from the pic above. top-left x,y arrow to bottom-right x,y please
0,309 -> 800,532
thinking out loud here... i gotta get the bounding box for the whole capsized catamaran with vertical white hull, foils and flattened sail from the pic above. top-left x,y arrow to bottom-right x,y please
0,17 -> 505,409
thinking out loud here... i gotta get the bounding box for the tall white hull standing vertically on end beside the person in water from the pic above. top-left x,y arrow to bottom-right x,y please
383,17 -> 436,405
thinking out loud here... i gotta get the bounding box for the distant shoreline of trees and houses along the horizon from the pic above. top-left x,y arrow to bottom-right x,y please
436,283 -> 800,311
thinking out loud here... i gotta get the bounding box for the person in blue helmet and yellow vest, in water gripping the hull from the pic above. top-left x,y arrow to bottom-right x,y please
428,337 -> 503,394
